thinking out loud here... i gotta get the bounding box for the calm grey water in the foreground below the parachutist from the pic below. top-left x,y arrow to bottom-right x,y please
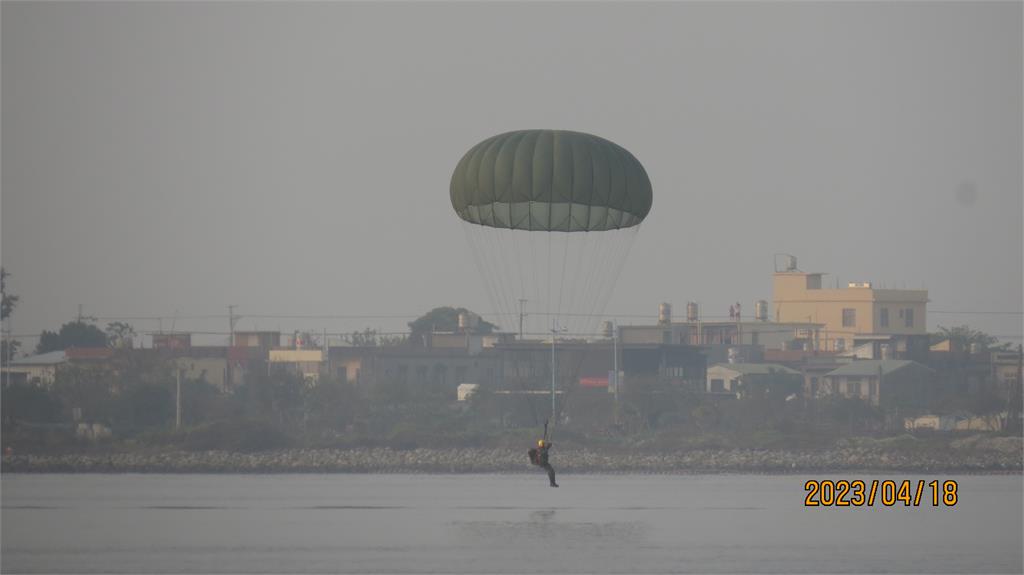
0,473 -> 1024,573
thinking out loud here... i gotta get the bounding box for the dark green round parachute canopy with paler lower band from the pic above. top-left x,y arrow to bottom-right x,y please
451,130 -> 652,231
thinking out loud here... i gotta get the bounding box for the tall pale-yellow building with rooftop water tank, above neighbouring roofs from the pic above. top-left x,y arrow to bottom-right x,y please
772,266 -> 928,351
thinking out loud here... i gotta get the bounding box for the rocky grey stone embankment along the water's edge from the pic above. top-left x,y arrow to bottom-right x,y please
0,448 -> 1024,475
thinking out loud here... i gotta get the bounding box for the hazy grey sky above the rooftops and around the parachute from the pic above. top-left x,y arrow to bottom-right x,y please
0,2 -> 1024,345
